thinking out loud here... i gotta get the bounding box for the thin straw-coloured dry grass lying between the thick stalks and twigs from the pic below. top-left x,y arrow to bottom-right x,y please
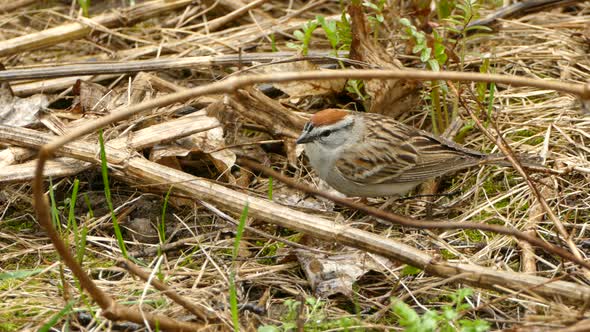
0,1 -> 590,331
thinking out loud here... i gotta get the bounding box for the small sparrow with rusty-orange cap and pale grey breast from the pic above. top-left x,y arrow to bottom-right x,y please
297,109 -> 512,196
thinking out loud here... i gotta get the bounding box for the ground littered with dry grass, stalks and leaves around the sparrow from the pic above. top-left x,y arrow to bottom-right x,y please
0,0 -> 590,331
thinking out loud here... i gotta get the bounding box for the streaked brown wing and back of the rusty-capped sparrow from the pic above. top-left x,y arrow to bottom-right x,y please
336,114 -> 486,184
